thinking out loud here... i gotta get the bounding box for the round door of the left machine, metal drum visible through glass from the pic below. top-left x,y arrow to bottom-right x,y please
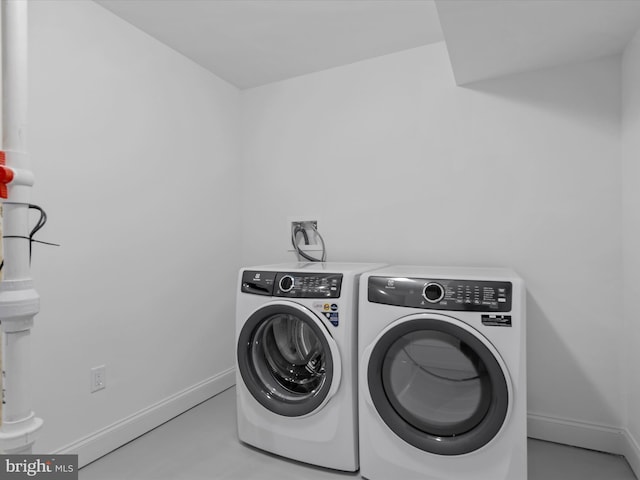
237,302 -> 341,417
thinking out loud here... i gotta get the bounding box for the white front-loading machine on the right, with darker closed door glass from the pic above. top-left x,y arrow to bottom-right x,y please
358,266 -> 527,480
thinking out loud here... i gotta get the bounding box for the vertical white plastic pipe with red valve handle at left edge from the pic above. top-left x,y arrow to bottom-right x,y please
0,0 -> 43,453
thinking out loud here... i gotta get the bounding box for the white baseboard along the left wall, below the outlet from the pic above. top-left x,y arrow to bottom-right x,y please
57,368 -> 235,467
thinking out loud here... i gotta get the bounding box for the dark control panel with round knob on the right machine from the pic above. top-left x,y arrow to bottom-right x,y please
368,276 -> 512,312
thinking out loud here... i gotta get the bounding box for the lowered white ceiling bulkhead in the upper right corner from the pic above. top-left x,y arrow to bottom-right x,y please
436,0 -> 640,85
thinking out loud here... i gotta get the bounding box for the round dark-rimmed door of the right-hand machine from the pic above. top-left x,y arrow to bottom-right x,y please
366,314 -> 513,455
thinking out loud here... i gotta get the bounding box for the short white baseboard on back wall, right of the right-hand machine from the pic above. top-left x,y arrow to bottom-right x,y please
527,413 -> 628,455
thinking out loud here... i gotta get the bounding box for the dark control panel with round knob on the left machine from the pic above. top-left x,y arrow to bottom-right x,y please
241,270 -> 342,298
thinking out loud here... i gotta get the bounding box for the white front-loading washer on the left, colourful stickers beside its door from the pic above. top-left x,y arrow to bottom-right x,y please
236,263 -> 382,471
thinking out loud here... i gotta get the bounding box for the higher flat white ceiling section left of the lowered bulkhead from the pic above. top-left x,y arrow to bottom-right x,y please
95,0 -> 443,88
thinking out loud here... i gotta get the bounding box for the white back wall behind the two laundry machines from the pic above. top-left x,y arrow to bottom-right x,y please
242,44 -> 624,438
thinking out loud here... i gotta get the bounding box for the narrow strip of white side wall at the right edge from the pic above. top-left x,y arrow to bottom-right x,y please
620,25 -> 640,472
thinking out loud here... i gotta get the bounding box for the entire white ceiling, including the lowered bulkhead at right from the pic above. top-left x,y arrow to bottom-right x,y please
95,0 -> 640,89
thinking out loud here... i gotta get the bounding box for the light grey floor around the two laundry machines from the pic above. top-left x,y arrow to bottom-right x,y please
79,388 -> 636,480
